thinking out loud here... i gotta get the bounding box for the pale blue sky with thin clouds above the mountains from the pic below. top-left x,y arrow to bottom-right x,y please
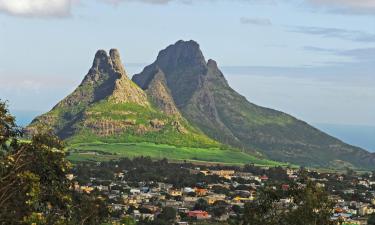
0,0 -> 375,126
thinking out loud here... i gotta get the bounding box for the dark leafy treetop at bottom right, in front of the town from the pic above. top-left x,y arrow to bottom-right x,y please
243,183 -> 334,225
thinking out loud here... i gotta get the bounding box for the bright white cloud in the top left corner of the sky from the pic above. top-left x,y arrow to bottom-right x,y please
0,0 -> 75,17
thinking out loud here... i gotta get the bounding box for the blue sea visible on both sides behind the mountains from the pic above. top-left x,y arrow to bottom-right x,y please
11,110 -> 375,152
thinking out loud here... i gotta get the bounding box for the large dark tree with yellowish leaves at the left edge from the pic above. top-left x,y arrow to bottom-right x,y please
0,99 -> 71,224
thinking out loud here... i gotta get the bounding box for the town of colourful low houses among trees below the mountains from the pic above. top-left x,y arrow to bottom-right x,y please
68,157 -> 375,225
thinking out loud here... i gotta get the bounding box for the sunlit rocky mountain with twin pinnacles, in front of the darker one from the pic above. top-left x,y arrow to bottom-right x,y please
27,49 -> 222,148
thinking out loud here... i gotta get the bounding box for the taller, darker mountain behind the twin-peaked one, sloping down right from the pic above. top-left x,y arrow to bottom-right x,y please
132,41 -> 375,168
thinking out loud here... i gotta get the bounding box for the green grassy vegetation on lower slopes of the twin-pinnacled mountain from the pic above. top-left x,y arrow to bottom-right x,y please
68,100 -> 223,148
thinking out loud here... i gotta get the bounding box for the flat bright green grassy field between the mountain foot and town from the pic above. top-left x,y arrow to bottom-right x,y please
68,142 -> 286,166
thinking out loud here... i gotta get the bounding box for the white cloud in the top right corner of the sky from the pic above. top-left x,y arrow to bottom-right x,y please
306,0 -> 375,14
